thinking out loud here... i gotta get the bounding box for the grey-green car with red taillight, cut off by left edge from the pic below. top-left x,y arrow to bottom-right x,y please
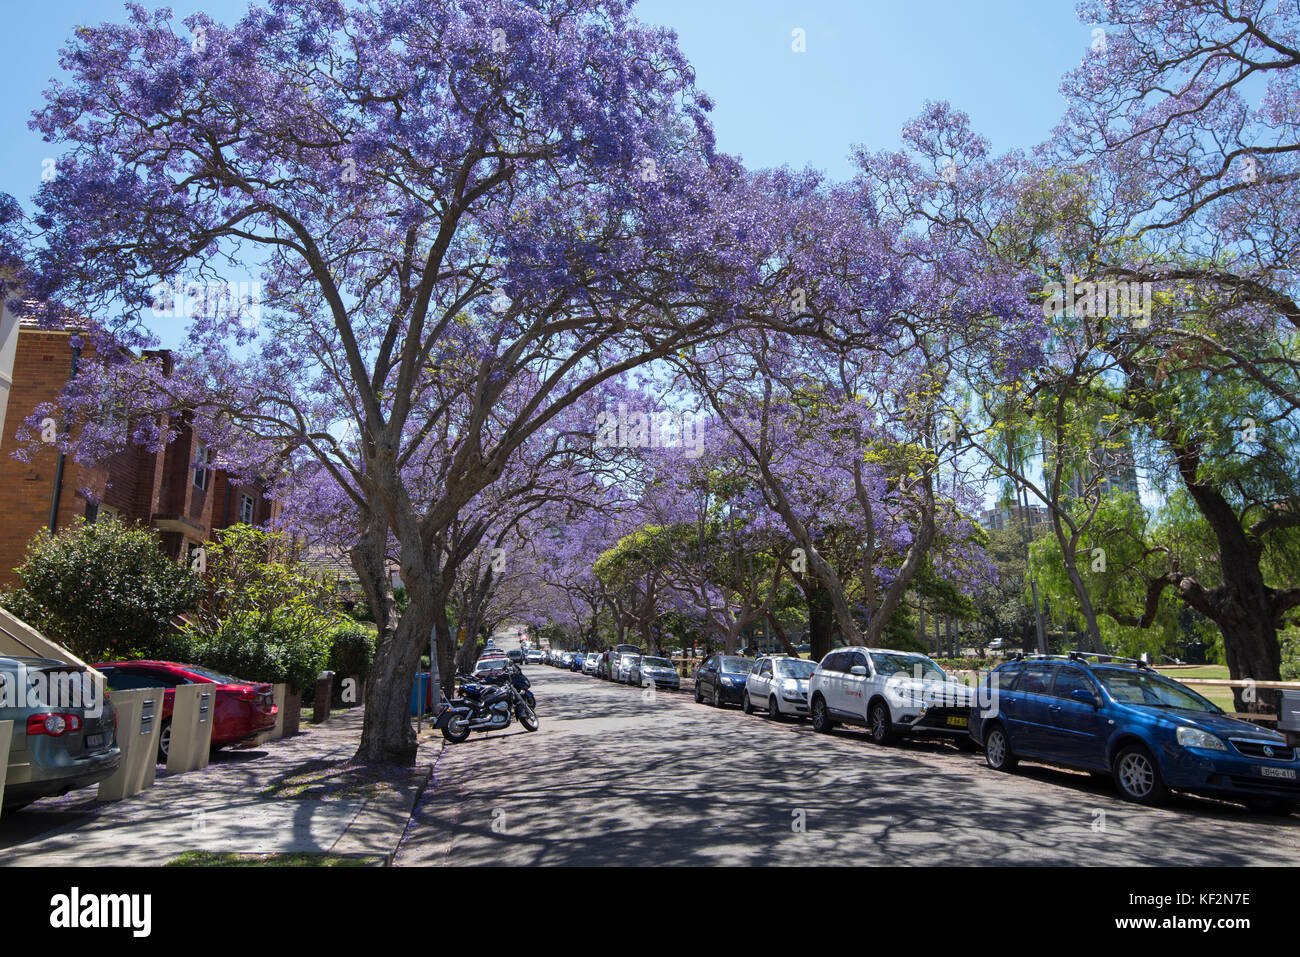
0,657 -> 122,811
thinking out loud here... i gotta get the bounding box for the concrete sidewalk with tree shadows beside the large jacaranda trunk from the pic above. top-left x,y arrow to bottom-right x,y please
0,707 -> 442,866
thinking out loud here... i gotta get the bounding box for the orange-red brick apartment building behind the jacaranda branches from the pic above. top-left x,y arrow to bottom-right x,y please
0,312 -> 273,586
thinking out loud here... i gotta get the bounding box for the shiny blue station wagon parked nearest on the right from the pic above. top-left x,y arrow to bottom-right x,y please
970,653 -> 1300,814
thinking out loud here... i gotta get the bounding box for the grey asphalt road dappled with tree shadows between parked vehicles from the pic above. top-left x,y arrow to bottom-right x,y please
397,664 -> 1300,866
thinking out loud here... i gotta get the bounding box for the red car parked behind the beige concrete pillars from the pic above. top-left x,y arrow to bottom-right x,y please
92,662 -> 280,763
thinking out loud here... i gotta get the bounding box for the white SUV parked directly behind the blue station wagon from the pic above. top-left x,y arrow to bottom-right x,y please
809,648 -> 975,750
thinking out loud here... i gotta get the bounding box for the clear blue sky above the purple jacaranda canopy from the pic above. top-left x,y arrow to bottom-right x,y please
0,0 -> 1092,203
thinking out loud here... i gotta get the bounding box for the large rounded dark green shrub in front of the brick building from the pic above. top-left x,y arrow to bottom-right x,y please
0,518 -> 203,662
